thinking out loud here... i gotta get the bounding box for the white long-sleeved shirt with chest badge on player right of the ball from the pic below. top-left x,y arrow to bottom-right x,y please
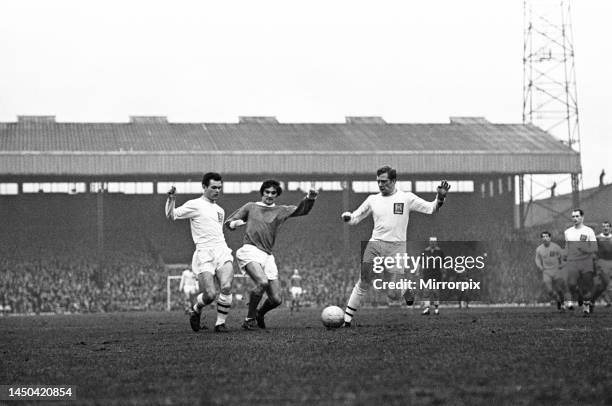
349,190 -> 438,241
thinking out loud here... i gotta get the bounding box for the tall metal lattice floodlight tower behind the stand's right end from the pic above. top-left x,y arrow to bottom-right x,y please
520,0 -> 580,220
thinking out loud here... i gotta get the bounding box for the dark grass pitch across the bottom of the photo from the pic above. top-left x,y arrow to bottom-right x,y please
0,308 -> 612,405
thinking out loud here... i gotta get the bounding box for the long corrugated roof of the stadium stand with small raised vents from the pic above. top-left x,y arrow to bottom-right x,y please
0,116 -> 580,177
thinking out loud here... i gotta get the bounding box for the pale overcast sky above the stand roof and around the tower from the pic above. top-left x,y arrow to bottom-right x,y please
0,0 -> 612,196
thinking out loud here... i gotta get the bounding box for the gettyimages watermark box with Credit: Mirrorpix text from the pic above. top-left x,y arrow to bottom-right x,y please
362,238 -> 489,301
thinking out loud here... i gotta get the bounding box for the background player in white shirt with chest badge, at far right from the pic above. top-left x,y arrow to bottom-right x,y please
564,209 -> 597,317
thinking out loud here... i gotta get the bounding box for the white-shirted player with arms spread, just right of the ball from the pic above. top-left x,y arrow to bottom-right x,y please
341,165 -> 450,327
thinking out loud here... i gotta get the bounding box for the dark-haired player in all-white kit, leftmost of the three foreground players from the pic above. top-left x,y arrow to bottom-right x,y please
166,172 -> 234,333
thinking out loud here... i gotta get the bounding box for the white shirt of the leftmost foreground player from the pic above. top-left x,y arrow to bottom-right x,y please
172,196 -> 225,248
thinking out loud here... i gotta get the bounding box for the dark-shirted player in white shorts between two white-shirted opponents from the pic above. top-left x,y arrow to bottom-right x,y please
225,180 -> 318,330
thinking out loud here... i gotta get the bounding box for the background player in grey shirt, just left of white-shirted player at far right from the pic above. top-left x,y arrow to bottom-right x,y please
535,231 -> 569,310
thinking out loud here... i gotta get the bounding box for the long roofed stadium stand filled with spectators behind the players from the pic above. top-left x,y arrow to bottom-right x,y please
0,117 -> 584,313
